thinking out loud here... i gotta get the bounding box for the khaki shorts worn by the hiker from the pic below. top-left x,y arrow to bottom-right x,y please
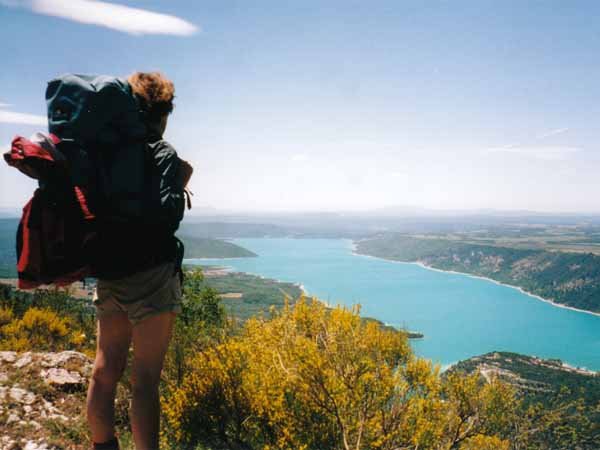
94,262 -> 181,325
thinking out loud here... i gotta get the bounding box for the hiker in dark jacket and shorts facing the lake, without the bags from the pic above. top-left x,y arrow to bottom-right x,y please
87,72 -> 192,450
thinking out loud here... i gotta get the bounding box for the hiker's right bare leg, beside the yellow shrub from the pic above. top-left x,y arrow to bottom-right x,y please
130,312 -> 175,450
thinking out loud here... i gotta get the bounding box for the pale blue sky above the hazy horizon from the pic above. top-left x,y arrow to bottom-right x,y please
0,0 -> 600,212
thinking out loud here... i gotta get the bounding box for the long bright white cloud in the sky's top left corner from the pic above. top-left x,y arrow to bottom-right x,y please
0,0 -> 198,36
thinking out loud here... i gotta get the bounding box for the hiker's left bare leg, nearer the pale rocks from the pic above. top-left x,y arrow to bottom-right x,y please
87,312 -> 131,443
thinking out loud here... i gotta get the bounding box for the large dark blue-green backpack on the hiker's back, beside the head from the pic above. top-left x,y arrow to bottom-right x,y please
46,74 -> 147,221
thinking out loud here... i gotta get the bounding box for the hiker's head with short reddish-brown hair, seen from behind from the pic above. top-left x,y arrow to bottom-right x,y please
127,72 -> 175,136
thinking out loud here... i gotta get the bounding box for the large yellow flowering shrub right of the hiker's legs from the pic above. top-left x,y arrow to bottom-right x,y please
162,298 -> 513,450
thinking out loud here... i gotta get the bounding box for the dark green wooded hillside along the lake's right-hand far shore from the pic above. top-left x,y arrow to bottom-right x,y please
356,234 -> 600,312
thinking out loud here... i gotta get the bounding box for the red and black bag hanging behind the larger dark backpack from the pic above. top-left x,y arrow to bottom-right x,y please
4,133 -> 95,289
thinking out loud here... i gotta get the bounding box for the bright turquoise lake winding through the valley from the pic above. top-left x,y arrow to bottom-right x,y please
186,238 -> 600,370
